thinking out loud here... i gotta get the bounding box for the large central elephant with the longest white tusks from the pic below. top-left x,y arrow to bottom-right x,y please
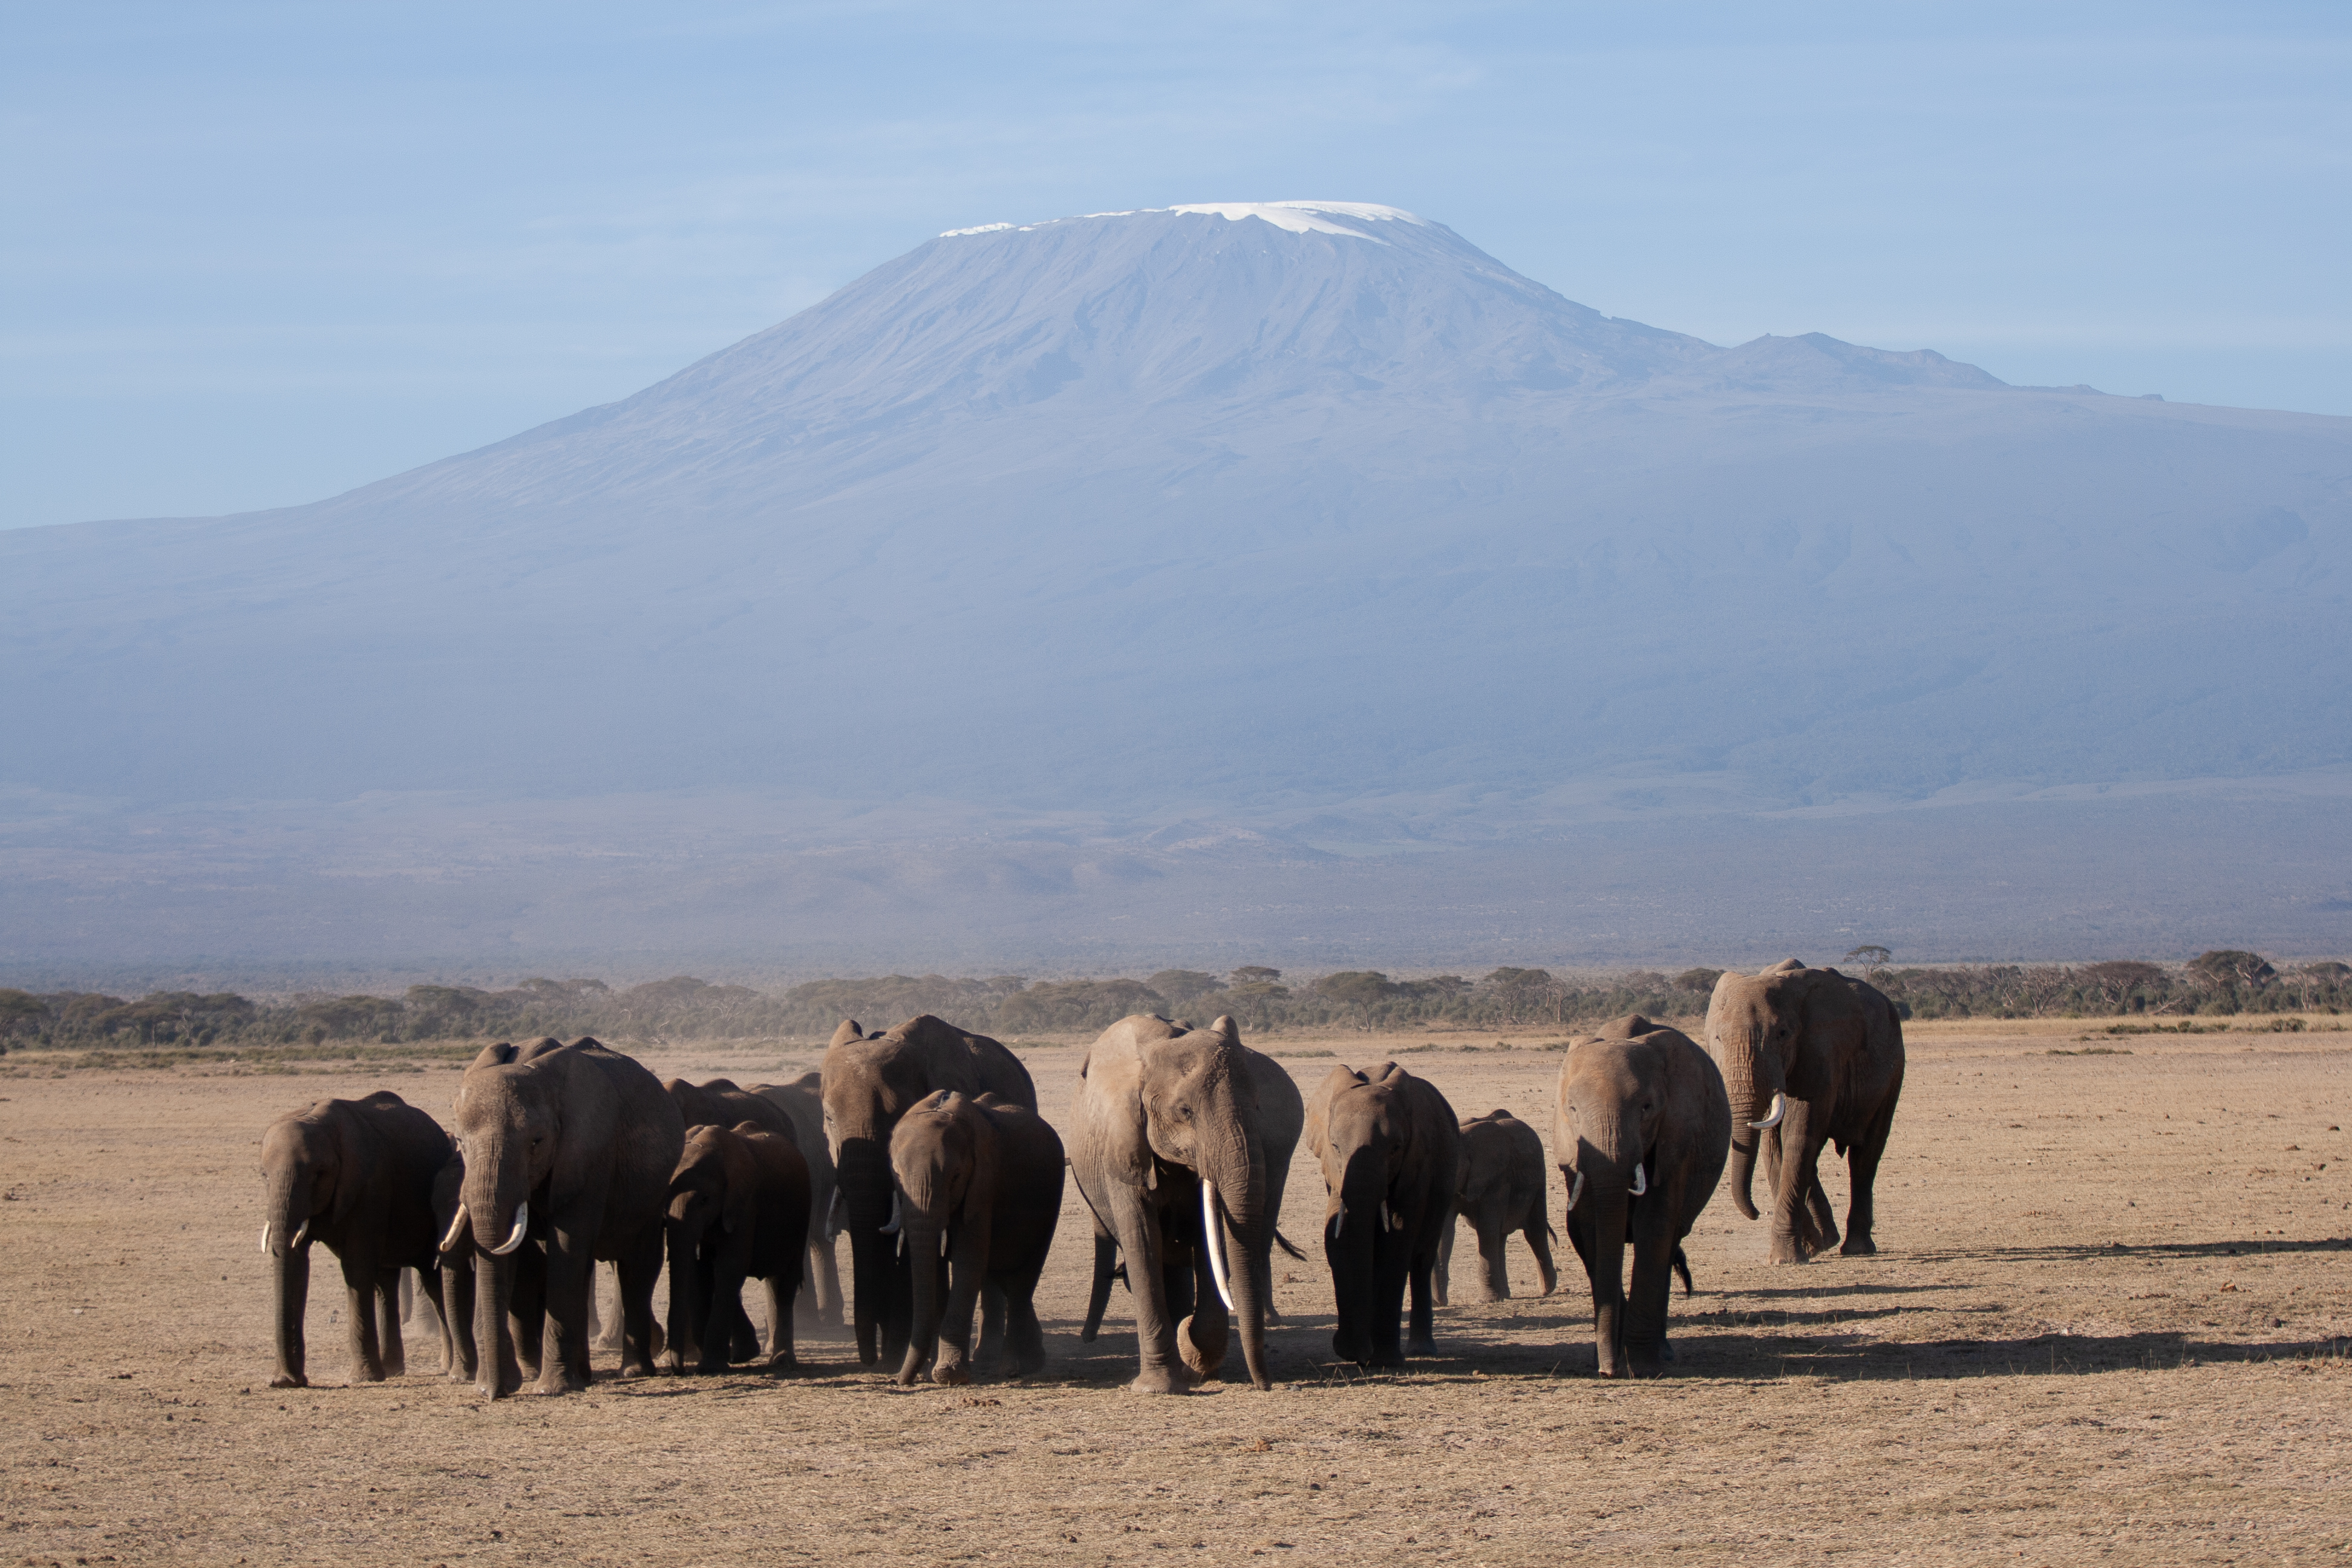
1068,1013 -> 1305,1394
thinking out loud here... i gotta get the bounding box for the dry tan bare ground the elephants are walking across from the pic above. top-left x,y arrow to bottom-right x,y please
0,1021 -> 2352,1563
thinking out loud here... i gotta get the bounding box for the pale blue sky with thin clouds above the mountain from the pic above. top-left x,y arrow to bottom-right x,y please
0,0 -> 2352,526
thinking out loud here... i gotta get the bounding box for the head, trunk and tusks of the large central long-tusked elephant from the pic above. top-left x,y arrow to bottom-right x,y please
1138,1018 -> 1277,1390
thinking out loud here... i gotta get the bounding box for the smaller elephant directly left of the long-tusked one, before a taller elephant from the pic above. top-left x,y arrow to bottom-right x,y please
889,1088 -> 1068,1385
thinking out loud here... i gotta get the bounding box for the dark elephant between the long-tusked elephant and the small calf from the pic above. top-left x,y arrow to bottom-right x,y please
1305,1062 -> 1463,1366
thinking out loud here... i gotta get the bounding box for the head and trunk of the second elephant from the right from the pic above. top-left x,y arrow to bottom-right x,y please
1552,1039 -> 1672,1377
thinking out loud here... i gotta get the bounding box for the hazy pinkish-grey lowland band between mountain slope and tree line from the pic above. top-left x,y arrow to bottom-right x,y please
0,776 -> 2352,992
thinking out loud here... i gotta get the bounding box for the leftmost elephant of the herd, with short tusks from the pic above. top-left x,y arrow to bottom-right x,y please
261,1088 -> 449,1390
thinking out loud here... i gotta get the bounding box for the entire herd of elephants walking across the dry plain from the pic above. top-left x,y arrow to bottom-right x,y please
261,959 -> 1903,1399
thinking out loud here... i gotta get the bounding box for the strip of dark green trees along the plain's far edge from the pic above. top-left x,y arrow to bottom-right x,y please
0,947 -> 2352,1048
